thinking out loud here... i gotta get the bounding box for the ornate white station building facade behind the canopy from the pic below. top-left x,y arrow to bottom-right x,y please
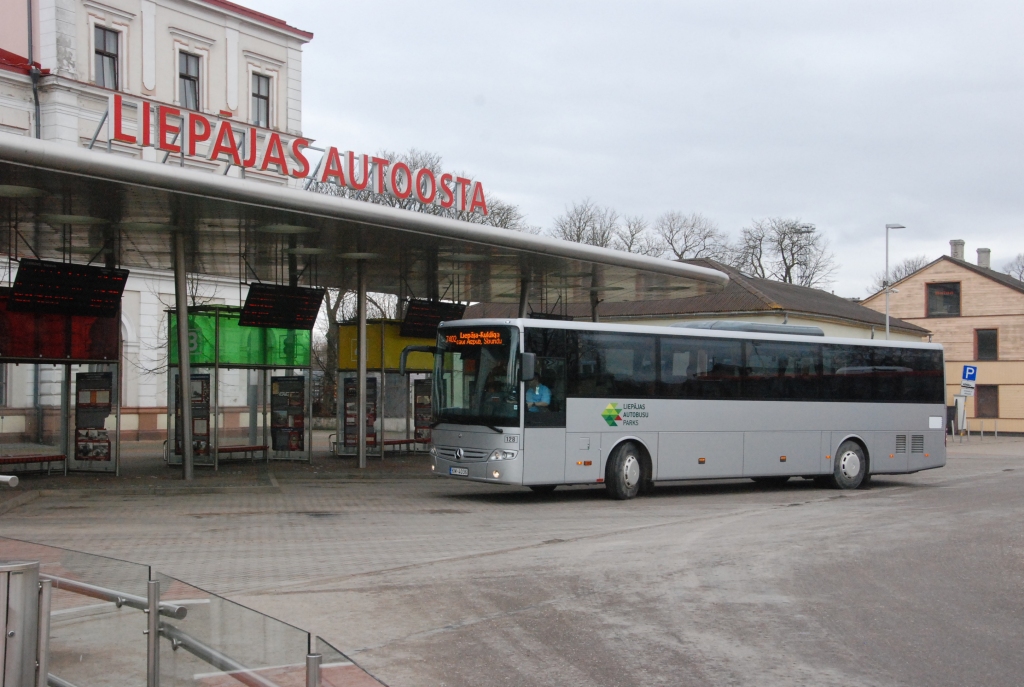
0,0 -> 312,441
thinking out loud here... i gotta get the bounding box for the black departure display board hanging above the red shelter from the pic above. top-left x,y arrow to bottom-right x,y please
7,259 -> 128,317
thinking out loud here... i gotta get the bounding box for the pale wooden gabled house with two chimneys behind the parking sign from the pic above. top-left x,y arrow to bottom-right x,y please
863,241 -> 1024,432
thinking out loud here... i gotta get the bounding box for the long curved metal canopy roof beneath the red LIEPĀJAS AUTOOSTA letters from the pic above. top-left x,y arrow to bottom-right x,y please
0,134 -> 728,304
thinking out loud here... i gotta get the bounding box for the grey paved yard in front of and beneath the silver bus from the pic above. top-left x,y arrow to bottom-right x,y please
0,438 -> 1024,687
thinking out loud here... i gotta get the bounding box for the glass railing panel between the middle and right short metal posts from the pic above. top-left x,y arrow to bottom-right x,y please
155,573 -> 311,687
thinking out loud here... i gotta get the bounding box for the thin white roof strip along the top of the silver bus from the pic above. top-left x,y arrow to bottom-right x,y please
440,317 -> 942,350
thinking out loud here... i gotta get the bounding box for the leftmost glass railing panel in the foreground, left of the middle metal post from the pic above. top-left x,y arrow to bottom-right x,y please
0,539 -> 150,687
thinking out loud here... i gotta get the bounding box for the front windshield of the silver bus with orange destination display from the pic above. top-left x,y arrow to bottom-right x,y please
433,327 -> 519,427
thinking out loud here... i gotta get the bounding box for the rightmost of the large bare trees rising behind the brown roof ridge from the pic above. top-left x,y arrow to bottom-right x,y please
732,217 -> 838,287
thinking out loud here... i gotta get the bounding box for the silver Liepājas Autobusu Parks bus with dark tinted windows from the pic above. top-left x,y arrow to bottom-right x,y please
430,319 -> 946,499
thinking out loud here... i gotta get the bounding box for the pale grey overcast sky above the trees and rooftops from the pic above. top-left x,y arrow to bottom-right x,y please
242,0 -> 1024,296
